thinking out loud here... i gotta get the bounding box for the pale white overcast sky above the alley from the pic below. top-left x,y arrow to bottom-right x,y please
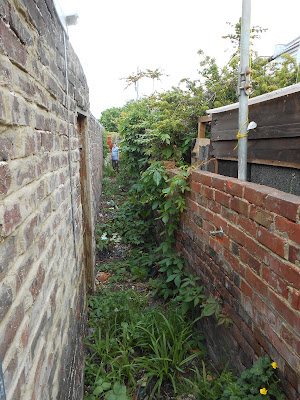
59,0 -> 300,118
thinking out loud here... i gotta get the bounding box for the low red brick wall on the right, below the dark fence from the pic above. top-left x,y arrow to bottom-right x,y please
177,171 -> 300,400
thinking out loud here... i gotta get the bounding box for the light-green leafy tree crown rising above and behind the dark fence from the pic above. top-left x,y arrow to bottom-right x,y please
119,20 -> 297,176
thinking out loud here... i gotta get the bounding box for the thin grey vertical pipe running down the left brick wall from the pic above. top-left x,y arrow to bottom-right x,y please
63,29 -> 78,272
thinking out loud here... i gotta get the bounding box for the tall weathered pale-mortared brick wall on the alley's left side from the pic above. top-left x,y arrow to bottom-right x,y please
0,0 -> 102,400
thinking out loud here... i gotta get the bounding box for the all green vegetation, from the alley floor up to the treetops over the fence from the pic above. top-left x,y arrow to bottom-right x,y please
85,24 -> 290,400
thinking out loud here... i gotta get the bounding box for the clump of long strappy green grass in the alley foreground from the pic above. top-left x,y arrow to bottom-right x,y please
85,290 -> 204,400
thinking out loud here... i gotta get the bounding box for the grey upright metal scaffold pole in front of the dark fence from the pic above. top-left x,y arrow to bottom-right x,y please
238,0 -> 251,181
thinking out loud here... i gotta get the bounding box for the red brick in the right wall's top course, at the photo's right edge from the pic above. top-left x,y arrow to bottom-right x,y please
265,189 -> 300,221
